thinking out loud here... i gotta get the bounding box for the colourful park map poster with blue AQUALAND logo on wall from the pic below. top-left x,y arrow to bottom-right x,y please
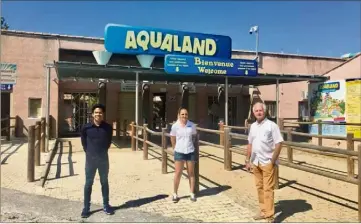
309,80 -> 346,136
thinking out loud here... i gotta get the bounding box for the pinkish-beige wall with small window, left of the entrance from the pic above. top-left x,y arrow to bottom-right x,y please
1,34 -> 58,135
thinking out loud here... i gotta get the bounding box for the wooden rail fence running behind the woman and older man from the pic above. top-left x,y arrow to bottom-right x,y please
130,122 -> 361,222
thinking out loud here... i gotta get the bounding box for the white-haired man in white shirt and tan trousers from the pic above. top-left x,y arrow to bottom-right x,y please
246,103 -> 283,222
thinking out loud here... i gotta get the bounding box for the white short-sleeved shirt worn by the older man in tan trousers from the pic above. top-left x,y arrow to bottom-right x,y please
248,118 -> 283,166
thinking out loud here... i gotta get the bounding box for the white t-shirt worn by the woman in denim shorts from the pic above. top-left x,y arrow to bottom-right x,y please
170,121 -> 197,154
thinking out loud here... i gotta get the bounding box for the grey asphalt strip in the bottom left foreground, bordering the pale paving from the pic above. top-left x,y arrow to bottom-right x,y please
1,188 -> 195,222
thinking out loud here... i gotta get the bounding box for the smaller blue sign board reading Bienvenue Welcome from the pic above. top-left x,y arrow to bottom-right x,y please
164,55 -> 258,76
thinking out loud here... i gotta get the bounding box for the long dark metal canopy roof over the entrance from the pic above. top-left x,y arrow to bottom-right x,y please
52,61 -> 328,86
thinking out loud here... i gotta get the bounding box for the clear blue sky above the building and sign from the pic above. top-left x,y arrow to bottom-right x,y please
1,1 -> 361,57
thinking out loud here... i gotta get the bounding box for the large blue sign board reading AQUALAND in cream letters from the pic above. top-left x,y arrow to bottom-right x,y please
104,24 -> 232,58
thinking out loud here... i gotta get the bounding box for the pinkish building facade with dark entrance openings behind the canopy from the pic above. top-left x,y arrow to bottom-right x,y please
1,31 -> 346,137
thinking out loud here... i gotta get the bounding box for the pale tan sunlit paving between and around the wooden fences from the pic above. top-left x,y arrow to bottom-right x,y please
1,136 -> 357,222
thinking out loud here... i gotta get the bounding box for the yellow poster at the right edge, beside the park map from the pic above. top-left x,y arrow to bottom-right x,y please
346,79 -> 361,138
